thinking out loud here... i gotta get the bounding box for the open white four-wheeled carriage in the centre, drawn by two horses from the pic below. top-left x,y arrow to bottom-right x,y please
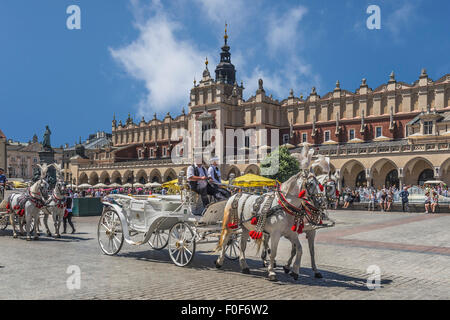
97,177 -> 240,266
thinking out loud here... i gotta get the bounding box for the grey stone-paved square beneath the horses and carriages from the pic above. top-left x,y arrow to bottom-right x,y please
0,205 -> 450,299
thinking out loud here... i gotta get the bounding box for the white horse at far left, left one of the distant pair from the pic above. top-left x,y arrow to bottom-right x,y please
7,164 -> 48,241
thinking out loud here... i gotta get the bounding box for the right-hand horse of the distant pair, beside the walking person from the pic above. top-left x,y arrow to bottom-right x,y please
43,164 -> 66,238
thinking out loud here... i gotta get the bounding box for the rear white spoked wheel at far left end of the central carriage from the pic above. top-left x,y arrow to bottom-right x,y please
97,210 -> 124,256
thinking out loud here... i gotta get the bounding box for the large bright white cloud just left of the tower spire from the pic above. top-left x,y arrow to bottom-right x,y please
110,1 -> 207,116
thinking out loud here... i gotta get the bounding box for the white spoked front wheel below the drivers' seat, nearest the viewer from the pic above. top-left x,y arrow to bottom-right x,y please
169,222 -> 195,267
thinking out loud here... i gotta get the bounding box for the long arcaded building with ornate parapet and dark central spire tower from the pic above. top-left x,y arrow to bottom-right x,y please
70,33 -> 450,187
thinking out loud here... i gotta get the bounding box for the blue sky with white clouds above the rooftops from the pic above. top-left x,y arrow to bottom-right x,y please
0,0 -> 450,147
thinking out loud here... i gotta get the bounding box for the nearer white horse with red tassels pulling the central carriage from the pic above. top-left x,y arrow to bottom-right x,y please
215,145 -> 330,281
